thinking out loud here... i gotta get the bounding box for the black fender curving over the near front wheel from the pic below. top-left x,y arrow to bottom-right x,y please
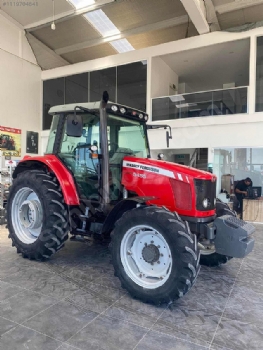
101,197 -> 156,233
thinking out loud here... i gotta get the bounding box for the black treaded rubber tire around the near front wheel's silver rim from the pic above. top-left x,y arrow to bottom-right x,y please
111,206 -> 199,304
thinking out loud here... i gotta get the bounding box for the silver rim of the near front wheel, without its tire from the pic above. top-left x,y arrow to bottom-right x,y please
120,226 -> 173,289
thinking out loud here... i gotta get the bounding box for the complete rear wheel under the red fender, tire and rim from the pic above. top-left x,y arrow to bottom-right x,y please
7,170 -> 68,260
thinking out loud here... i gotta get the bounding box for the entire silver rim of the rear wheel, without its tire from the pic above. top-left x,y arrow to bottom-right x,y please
11,187 -> 43,244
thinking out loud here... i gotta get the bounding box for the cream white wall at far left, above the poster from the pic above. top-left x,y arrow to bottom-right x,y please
0,14 -> 42,156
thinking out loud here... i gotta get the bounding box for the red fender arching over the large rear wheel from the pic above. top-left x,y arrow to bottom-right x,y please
13,155 -> 80,205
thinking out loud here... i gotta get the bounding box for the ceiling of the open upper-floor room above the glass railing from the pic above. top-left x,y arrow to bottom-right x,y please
161,39 -> 250,92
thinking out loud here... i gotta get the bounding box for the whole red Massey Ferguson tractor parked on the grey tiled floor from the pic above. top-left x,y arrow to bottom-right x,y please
7,93 -> 254,304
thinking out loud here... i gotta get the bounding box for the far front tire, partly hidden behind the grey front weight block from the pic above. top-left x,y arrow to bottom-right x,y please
200,200 -> 237,267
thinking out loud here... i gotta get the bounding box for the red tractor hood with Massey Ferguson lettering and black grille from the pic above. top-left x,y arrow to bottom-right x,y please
122,156 -> 216,217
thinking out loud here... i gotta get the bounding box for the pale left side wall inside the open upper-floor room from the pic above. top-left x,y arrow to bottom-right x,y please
150,57 -> 178,98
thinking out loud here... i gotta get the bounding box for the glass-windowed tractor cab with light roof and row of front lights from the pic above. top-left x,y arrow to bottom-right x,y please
46,98 -> 150,204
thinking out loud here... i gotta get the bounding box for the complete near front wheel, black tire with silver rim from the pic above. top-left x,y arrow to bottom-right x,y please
112,207 -> 200,304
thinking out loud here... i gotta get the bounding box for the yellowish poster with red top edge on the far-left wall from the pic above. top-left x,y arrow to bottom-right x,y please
0,126 -> 21,157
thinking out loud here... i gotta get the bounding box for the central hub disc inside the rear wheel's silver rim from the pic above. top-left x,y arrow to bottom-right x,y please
19,200 -> 43,229
